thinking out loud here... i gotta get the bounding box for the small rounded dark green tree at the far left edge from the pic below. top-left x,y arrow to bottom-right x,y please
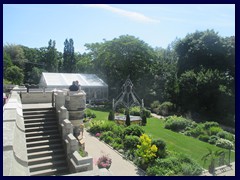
5,66 -> 24,85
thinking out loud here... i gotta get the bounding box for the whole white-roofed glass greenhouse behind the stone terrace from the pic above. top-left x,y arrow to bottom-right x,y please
39,72 -> 108,102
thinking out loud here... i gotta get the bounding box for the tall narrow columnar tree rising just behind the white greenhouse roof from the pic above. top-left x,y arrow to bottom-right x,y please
62,39 -> 76,73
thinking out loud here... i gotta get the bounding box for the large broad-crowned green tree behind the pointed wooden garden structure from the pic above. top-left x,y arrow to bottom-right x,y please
85,35 -> 154,98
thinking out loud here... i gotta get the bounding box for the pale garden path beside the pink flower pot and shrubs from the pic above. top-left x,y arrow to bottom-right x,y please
83,131 -> 144,176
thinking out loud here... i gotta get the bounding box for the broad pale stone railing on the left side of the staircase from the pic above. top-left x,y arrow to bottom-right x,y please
3,92 -> 29,176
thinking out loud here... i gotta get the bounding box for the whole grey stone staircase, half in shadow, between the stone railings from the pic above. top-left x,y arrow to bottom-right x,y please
23,108 -> 69,176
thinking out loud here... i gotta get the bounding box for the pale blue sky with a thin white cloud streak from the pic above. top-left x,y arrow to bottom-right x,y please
3,4 -> 235,53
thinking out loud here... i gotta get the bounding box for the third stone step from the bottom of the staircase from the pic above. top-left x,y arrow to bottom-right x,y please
28,153 -> 66,166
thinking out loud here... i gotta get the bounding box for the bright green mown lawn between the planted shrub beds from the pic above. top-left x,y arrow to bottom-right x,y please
87,109 -> 235,168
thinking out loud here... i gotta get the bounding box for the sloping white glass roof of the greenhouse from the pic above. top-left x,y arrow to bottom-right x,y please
39,72 -> 107,87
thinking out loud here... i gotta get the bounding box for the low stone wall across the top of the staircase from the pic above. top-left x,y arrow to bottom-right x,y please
20,91 -> 52,104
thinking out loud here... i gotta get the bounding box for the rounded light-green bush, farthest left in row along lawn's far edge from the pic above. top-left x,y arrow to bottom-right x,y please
165,116 -> 192,132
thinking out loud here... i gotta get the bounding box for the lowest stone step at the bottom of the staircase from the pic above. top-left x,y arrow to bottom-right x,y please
30,166 -> 69,176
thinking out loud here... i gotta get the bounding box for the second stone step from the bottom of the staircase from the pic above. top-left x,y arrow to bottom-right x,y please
29,160 -> 68,172
